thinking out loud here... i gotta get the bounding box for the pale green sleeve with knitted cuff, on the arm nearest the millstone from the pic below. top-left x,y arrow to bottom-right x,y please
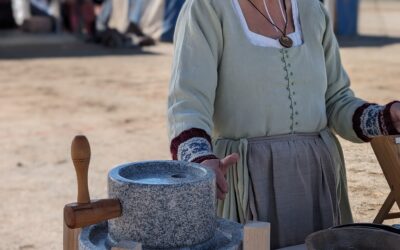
168,0 -> 223,162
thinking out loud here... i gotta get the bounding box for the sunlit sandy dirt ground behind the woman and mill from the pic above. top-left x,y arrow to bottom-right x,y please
0,1 -> 400,250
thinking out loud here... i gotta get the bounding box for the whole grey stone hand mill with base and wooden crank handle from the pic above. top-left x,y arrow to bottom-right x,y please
64,136 -> 243,250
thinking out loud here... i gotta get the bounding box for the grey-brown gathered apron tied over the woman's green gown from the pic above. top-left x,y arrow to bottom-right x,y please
246,133 -> 339,249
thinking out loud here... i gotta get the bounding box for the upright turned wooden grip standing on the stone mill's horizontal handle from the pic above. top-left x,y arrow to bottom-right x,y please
71,135 -> 90,203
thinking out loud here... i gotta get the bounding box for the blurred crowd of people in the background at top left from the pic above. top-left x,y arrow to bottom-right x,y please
0,0 -> 184,47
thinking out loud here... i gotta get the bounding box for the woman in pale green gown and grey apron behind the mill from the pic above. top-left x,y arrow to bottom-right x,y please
168,0 -> 400,248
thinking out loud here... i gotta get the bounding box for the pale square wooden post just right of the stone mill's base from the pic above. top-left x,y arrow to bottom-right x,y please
243,221 -> 271,250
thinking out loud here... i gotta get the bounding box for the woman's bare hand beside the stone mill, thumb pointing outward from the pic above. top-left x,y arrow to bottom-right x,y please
201,153 -> 239,200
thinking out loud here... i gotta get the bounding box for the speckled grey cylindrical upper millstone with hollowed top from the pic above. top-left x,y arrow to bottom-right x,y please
108,161 -> 217,249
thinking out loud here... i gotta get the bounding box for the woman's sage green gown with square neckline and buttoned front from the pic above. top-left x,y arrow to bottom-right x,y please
168,0 -> 365,247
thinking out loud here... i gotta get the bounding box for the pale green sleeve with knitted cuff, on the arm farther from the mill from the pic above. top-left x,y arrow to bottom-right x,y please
321,4 -> 397,142
